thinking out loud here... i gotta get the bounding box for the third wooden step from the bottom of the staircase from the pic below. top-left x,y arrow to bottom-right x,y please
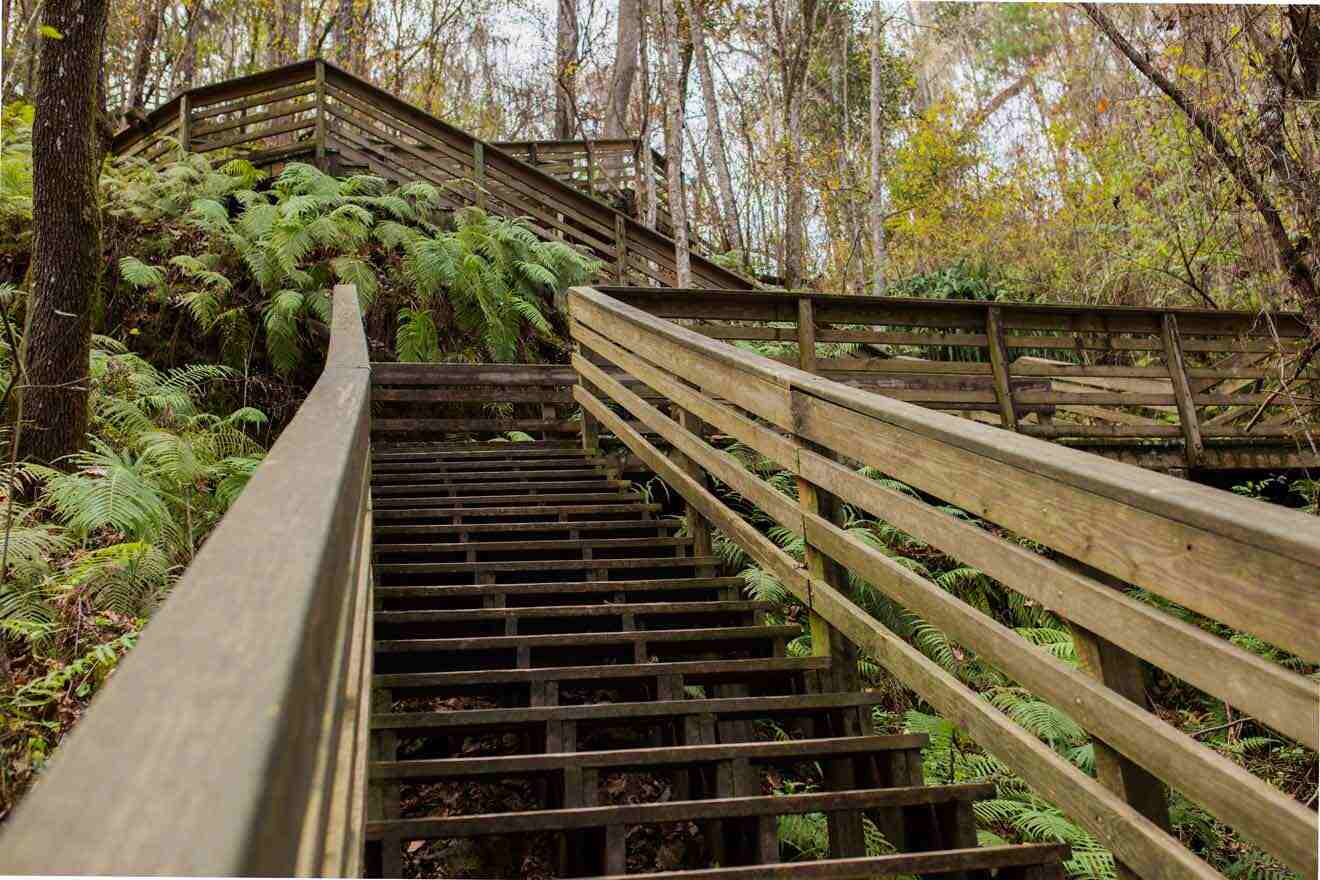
370,734 -> 929,780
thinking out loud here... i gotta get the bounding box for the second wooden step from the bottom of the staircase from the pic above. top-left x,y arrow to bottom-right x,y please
367,782 -> 995,840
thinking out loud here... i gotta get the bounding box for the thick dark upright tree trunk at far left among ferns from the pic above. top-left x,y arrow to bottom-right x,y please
18,0 -> 110,463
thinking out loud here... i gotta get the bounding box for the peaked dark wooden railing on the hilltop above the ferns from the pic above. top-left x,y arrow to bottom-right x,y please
111,59 -> 750,288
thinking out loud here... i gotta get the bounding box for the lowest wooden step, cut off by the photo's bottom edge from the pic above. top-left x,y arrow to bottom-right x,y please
586,843 -> 1072,880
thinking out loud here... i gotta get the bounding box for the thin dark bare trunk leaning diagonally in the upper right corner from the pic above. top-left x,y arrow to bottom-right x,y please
1081,3 -> 1320,344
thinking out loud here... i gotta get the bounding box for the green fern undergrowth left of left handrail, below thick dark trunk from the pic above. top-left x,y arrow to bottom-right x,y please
0,338 -> 265,818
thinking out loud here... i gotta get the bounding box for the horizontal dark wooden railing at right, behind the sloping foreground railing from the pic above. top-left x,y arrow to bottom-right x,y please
602,288 -> 1320,470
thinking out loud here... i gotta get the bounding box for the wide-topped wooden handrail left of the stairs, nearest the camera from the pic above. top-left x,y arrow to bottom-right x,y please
0,286 -> 371,876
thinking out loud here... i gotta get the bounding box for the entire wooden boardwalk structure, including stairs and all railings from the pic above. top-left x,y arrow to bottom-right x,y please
0,62 -> 1320,880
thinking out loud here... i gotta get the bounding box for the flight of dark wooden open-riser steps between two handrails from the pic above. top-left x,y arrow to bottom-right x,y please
367,441 -> 1067,877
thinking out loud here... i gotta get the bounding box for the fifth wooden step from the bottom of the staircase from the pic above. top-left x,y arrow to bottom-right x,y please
372,657 -> 829,690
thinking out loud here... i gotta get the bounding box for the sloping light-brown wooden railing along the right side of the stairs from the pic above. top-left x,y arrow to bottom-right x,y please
569,288 -> 1320,879
